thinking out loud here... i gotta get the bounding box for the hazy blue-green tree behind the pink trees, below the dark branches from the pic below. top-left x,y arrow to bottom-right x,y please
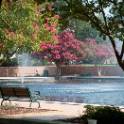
69,19 -> 106,43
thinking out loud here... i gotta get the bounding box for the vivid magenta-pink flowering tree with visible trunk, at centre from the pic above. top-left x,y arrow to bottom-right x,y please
35,31 -> 82,76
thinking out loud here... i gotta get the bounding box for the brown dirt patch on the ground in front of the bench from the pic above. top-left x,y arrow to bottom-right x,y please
0,107 -> 56,116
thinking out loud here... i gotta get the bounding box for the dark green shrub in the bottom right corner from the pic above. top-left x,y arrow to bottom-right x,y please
83,105 -> 124,124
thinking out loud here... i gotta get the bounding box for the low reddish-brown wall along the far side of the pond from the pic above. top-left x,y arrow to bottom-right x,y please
0,65 -> 124,77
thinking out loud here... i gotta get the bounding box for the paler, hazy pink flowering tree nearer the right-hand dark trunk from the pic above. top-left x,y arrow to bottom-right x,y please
82,38 -> 113,64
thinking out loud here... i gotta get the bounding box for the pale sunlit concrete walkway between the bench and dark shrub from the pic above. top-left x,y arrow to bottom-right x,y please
0,99 -> 85,120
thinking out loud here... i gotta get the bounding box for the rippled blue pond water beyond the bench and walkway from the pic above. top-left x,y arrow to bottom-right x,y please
0,80 -> 124,105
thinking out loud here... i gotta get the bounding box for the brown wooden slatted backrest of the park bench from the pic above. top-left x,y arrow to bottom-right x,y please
0,87 -> 30,97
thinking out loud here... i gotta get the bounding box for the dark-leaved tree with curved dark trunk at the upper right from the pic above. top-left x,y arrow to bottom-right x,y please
55,0 -> 124,70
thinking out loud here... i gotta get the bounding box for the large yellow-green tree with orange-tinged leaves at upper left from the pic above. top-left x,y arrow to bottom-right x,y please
0,0 -> 56,65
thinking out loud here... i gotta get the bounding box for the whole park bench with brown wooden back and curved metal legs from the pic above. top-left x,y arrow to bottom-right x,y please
0,87 -> 40,108
